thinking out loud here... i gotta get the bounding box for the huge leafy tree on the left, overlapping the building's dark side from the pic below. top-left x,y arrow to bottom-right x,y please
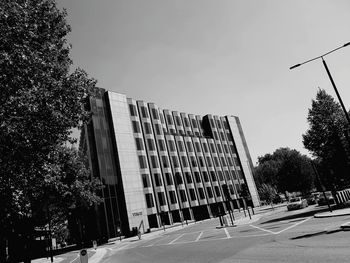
0,0 -> 101,262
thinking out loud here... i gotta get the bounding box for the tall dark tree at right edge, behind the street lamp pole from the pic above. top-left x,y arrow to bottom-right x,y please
303,89 -> 350,192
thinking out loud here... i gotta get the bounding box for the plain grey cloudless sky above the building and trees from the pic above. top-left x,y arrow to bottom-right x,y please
57,0 -> 350,164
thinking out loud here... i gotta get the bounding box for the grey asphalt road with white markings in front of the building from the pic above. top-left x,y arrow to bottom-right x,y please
100,207 -> 350,263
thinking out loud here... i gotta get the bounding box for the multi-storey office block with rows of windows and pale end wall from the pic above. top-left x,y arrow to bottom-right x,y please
81,90 -> 259,238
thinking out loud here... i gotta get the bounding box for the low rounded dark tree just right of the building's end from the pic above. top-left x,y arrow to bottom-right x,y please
255,148 -> 314,192
